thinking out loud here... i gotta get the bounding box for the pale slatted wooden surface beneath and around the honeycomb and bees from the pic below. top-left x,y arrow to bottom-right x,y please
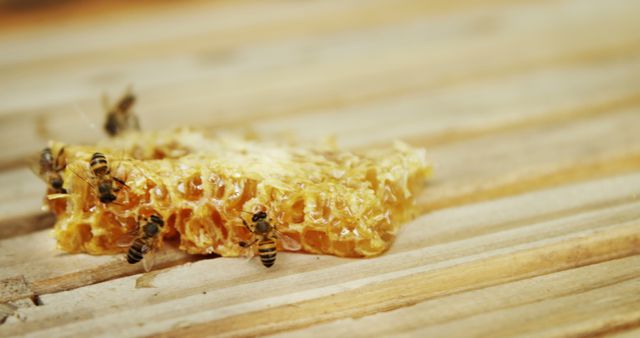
0,0 -> 640,337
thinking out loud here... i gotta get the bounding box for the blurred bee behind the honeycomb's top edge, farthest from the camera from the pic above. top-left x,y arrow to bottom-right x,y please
102,87 -> 140,137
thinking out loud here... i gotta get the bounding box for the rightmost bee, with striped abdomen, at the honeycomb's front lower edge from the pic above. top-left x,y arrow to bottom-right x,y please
239,211 -> 300,268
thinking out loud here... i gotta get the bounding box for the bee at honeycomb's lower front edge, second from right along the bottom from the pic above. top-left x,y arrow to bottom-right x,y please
118,215 -> 164,271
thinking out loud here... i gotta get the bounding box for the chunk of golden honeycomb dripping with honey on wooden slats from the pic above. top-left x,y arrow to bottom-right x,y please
47,129 -> 431,257
